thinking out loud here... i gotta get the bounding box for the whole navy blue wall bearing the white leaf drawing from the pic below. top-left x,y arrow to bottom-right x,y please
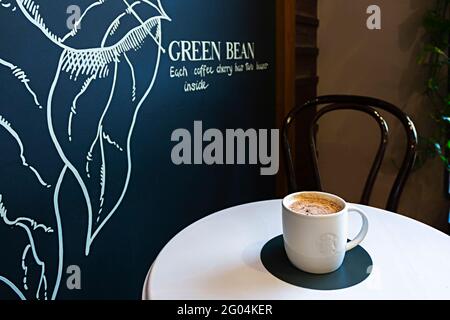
0,0 -> 275,299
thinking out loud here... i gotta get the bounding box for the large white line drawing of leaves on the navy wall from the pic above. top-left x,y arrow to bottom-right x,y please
0,0 -> 171,299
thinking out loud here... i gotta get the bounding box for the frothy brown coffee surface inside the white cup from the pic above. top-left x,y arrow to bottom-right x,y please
288,195 -> 344,216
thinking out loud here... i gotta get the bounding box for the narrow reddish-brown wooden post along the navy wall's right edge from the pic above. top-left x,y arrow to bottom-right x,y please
276,0 -> 296,197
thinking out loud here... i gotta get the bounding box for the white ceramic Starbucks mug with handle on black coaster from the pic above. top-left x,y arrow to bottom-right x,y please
282,192 -> 369,274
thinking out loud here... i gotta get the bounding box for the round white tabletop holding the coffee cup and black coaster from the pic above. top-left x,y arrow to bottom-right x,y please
143,200 -> 450,300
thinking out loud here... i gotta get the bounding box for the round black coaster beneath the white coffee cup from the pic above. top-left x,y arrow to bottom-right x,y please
261,235 -> 372,290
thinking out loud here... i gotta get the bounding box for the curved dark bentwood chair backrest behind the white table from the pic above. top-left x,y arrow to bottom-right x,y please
282,95 -> 418,212
